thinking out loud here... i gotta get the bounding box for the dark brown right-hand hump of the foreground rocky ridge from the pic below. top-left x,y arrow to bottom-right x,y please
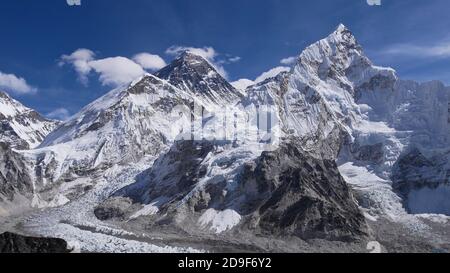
242,142 -> 366,240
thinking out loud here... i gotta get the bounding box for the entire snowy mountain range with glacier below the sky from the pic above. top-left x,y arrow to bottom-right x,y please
0,25 -> 450,252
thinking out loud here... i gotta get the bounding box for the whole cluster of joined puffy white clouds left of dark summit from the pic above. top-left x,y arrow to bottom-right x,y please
59,48 -> 166,86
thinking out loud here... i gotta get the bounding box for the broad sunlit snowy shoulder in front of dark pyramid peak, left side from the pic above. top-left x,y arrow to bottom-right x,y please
27,75 -> 207,189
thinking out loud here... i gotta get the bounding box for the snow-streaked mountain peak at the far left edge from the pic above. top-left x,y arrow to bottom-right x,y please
0,91 -> 58,149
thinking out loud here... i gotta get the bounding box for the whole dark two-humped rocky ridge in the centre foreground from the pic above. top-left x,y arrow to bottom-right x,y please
103,140 -> 367,241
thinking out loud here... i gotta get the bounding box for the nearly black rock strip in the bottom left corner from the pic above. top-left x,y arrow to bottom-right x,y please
0,232 -> 70,253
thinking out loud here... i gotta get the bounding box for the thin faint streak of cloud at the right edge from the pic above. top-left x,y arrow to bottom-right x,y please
381,41 -> 450,58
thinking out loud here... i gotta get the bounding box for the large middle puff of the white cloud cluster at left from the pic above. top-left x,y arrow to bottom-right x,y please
89,57 -> 145,86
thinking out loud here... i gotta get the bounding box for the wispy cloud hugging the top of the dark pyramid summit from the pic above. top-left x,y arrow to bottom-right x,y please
166,46 -> 237,79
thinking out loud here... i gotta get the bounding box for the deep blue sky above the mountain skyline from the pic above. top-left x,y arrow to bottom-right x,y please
0,0 -> 450,117
